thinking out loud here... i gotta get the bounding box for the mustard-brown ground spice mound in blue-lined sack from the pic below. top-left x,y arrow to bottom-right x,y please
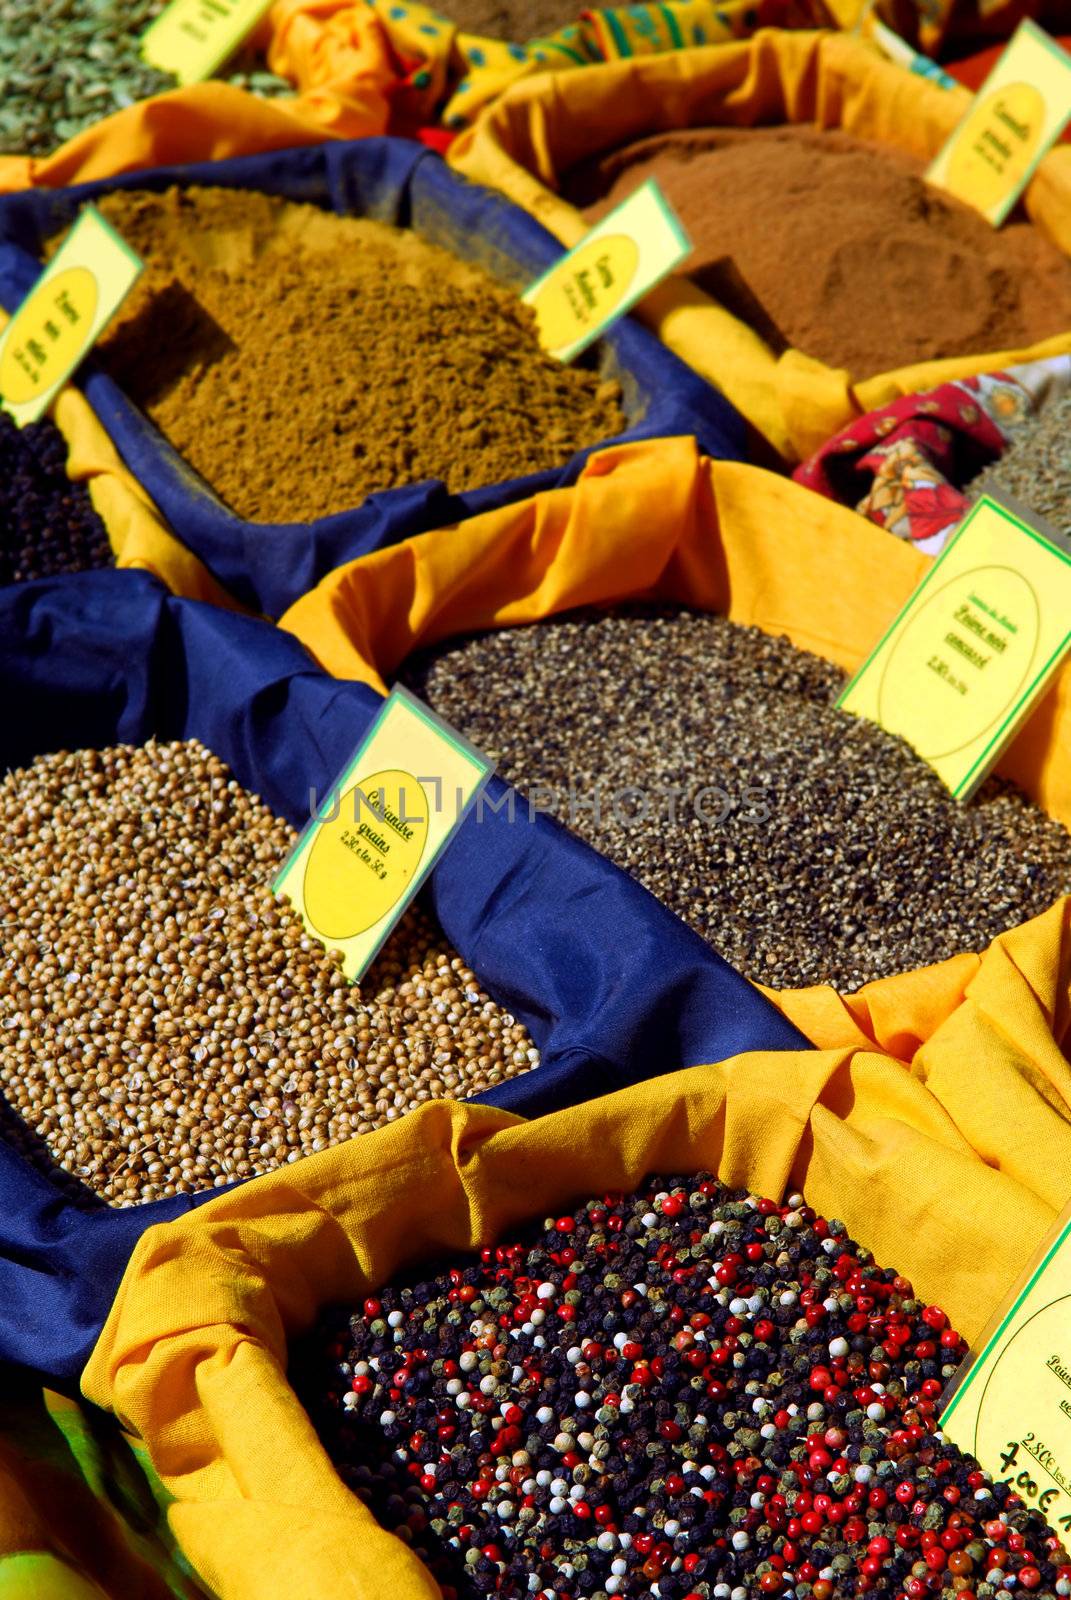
89,189 -> 626,522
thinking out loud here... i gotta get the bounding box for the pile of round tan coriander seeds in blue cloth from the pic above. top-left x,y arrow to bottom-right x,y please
0,741 -> 538,1205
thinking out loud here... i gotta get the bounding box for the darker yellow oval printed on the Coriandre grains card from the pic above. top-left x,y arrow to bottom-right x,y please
304,768 -> 431,942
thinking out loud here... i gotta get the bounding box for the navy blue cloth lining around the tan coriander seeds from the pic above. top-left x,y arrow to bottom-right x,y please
0,571 -> 807,1382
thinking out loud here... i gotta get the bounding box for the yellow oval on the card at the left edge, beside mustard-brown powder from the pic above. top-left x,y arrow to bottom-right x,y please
0,267 -> 99,405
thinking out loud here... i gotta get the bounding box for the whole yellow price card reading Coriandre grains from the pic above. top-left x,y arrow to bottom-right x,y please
272,688 -> 495,982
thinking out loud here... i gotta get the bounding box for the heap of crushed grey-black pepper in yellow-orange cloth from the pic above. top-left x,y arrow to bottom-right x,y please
405,608 -> 1071,990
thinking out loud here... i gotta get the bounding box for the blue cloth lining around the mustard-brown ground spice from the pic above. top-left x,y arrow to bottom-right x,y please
0,138 -> 744,618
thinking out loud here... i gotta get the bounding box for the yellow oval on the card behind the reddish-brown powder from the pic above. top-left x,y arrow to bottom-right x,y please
945,83 -> 1045,211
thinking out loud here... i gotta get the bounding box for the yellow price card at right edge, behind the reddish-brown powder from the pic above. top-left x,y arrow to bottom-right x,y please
925,21 -> 1071,227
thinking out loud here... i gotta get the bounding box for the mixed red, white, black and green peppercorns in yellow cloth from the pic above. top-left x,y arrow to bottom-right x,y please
296,1176 -> 1071,1600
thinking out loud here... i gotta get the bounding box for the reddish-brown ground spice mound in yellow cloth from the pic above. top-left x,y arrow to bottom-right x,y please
564,126 -> 1071,379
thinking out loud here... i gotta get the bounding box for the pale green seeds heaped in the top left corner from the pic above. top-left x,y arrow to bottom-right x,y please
0,0 -> 293,155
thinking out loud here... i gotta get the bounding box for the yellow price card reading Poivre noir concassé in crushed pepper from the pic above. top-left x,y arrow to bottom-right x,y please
837,494 -> 1071,800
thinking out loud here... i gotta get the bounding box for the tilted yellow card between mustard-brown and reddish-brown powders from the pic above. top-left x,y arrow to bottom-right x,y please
520,178 -> 692,362
